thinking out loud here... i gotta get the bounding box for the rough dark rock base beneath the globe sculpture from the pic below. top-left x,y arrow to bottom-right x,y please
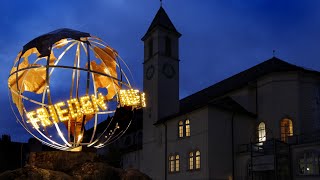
0,151 -> 150,180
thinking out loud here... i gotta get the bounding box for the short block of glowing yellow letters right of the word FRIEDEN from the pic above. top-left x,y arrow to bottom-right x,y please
119,89 -> 146,108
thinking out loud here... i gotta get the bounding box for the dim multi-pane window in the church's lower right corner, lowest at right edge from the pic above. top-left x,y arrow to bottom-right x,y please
298,151 -> 320,175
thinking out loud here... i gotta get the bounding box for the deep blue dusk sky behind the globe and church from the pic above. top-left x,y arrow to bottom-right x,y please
0,0 -> 320,141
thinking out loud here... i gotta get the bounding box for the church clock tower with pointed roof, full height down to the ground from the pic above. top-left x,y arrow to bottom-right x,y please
141,7 -> 181,179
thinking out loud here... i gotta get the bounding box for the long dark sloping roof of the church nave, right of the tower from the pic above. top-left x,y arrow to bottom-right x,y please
155,57 -> 320,124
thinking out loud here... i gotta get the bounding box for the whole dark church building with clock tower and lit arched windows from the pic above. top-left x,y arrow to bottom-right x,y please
123,7 -> 320,180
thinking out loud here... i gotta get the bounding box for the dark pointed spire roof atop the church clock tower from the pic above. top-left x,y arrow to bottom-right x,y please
142,6 -> 181,40
